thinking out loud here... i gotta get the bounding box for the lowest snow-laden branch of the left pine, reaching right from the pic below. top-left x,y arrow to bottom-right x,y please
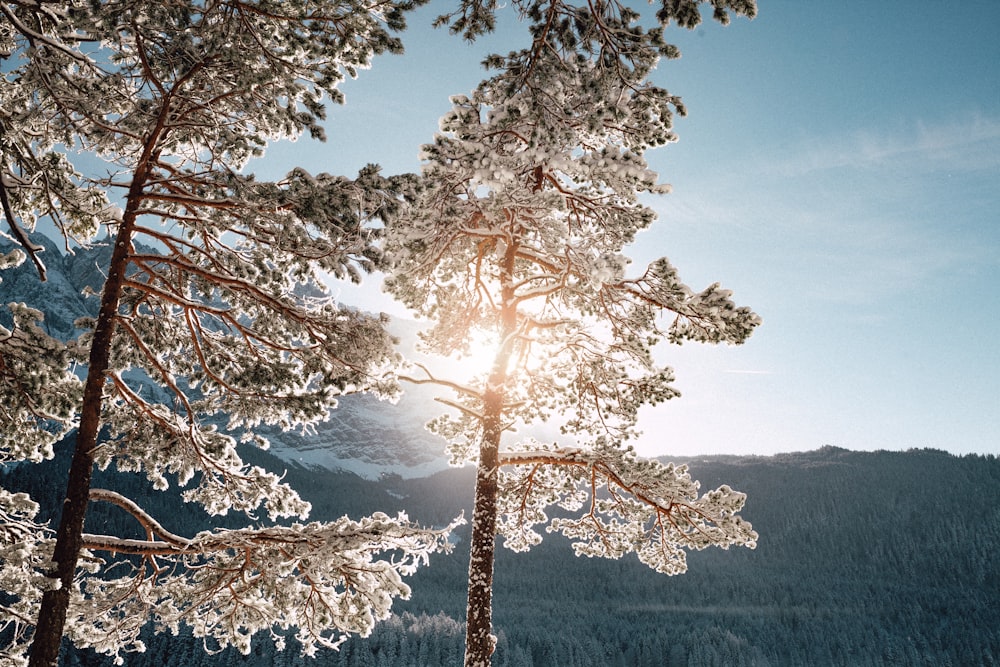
72,490 -> 465,657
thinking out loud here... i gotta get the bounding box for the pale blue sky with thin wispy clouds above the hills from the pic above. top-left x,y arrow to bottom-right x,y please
256,0 -> 1000,455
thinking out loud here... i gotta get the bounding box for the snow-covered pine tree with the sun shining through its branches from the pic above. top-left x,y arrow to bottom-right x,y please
387,0 -> 759,667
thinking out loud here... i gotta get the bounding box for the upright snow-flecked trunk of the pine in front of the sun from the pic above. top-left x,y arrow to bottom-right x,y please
465,243 -> 518,667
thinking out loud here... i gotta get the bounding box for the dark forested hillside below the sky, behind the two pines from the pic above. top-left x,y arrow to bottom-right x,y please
2,440 -> 1000,667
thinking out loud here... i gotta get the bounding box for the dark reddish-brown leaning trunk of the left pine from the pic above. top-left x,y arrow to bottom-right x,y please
28,175 -> 145,667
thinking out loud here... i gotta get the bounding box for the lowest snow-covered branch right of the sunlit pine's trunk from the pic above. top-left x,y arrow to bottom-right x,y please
499,440 -> 757,575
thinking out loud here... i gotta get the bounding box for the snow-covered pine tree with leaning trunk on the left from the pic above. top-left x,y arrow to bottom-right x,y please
0,0 -> 462,667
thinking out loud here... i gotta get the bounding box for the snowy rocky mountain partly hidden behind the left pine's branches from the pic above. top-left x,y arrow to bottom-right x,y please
0,234 -> 447,477
